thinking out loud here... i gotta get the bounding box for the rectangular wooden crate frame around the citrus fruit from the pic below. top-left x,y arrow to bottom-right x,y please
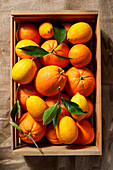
11,10 -> 102,155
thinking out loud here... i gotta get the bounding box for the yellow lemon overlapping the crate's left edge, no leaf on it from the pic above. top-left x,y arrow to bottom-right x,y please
12,59 -> 37,84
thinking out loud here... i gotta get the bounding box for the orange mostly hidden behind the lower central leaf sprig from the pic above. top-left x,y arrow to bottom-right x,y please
45,93 -> 70,118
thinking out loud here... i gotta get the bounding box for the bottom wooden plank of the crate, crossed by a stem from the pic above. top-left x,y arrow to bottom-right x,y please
12,145 -> 100,156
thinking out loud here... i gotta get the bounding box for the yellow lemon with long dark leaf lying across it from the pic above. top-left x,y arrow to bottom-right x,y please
15,40 -> 39,59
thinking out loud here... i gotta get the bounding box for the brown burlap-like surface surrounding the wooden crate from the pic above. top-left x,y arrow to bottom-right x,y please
0,0 -> 113,170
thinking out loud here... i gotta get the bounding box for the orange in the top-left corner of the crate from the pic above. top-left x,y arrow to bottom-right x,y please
16,24 -> 40,44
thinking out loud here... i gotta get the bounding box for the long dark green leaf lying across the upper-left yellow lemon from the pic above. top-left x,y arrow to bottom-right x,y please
19,46 -> 49,57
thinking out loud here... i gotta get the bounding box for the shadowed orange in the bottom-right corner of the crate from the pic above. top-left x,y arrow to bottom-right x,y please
74,120 -> 95,145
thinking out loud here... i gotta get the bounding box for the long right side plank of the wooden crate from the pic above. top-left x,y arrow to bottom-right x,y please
95,14 -> 102,154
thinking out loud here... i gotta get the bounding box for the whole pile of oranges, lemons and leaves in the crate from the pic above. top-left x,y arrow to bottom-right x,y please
11,22 -> 95,153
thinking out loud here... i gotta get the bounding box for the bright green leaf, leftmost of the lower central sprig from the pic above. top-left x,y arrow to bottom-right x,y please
43,103 -> 57,125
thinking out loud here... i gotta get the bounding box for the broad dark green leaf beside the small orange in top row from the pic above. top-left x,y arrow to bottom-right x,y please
53,25 -> 66,45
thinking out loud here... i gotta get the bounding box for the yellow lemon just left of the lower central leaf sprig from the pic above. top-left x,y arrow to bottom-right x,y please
26,96 -> 47,121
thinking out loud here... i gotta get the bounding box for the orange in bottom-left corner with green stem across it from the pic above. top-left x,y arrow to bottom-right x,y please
16,112 -> 46,143
